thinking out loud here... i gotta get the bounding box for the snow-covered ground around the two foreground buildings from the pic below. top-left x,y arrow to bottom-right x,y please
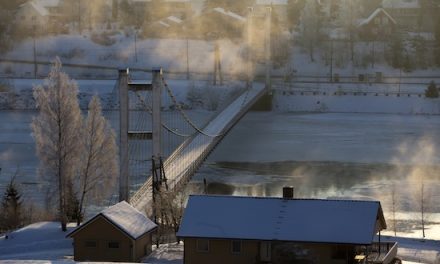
0,222 -> 440,264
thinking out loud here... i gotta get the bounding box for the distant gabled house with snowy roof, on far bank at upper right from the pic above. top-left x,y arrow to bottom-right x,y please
358,8 -> 397,40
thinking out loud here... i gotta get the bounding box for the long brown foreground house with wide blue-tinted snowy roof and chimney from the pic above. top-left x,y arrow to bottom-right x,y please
177,188 -> 397,264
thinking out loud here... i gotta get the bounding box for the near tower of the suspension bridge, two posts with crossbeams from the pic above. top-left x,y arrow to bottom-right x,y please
119,68 -> 166,202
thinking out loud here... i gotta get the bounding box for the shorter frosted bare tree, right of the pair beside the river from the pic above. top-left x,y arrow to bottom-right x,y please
76,96 -> 118,225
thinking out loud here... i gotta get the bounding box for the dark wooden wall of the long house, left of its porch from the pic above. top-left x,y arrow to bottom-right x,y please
184,238 -> 259,264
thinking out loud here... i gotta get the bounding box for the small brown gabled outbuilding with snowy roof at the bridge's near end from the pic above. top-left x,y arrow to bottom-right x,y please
67,201 -> 157,262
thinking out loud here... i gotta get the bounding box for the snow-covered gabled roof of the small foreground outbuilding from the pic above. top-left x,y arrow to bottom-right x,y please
67,201 -> 157,240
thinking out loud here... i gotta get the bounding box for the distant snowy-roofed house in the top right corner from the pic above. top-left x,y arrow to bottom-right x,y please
382,0 -> 423,30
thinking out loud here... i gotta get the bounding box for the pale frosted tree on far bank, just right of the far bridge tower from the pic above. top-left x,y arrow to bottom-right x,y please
301,0 -> 323,61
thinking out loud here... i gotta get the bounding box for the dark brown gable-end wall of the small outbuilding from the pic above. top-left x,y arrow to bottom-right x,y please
73,216 -> 133,261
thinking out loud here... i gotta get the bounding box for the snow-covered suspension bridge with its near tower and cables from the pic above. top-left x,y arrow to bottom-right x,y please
111,69 -> 268,211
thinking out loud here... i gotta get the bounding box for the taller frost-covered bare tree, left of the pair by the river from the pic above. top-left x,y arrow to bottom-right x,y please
31,58 -> 82,231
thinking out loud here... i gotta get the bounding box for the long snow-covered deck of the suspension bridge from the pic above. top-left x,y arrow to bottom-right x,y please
130,83 -> 265,210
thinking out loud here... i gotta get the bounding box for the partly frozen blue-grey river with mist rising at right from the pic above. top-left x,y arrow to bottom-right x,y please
0,111 -> 440,239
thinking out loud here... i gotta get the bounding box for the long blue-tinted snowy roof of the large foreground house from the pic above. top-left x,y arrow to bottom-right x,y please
177,195 -> 386,245
